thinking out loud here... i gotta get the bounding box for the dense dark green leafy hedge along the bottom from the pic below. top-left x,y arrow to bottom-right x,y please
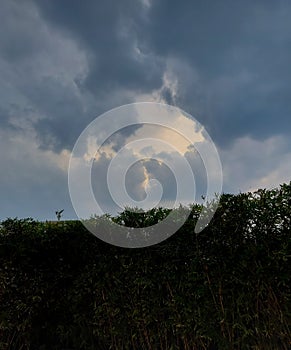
0,183 -> 291,350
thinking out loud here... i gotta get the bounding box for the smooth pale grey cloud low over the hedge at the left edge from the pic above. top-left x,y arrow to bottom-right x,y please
0,129 -> 75,220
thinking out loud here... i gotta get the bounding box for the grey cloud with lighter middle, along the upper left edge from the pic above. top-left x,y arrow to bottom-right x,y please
0,1 -> 92,152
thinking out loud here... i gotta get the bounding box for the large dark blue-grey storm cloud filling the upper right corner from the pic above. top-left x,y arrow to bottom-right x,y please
140,0 -> 291,145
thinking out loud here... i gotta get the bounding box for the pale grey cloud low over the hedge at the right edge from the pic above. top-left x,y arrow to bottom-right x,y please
220,136 -> 291,193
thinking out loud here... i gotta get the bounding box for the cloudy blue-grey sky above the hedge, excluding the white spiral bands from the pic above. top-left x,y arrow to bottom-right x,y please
0,0 -> 291,220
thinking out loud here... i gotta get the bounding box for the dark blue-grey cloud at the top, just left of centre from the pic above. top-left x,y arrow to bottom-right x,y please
36,0 -> 163,96
